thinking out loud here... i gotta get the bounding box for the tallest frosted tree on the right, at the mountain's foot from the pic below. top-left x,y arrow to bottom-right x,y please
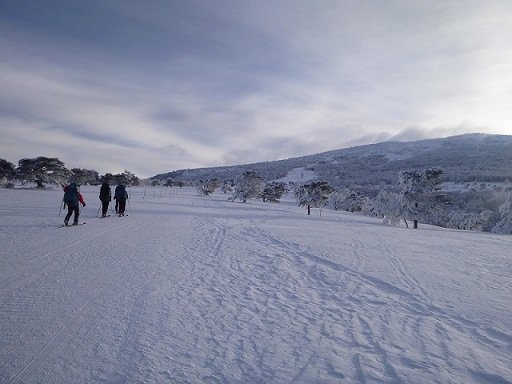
399,167 -> 444,224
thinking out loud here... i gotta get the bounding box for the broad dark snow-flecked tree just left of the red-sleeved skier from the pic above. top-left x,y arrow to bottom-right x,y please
16,156 -> 72,188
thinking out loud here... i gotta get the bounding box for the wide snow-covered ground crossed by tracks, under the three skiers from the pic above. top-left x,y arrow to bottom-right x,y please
0,187 -> 512,384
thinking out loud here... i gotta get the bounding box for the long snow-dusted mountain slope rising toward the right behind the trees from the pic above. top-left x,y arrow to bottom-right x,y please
152,133 -> 512,189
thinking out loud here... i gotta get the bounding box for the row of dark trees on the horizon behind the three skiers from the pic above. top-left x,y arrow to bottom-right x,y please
0,156 -> 142,188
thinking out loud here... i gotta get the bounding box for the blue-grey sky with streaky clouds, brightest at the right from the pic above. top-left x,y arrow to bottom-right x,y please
0,0 -> 512,177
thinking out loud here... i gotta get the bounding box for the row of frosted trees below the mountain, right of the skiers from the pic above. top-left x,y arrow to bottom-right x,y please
194,167 -> 512,234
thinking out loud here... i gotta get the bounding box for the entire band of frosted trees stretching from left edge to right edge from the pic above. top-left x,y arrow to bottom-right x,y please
5,156 -> 512,234
